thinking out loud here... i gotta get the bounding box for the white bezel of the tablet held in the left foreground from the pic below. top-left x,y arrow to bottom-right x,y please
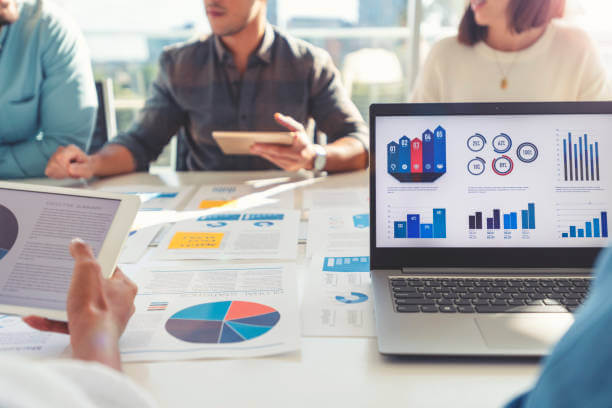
0,181 -> 140,321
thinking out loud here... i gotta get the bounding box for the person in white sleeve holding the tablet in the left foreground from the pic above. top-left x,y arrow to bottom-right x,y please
0,239 -> 157,408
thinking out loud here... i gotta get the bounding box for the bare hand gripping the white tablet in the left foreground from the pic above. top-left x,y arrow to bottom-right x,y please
23,239 -> 138,370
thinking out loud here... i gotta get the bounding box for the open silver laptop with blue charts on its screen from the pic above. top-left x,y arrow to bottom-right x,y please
370,102 -> 612,356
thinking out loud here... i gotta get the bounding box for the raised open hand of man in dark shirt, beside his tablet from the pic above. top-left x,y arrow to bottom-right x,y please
251,113 -> 316,171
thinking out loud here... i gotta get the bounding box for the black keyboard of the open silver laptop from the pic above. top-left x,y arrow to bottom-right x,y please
389,277 -> 591,313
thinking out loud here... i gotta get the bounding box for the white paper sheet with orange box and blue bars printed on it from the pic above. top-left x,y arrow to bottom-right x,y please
155,210 -> 300,260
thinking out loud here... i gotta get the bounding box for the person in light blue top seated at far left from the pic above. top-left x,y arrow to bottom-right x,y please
0,0 -> 98,179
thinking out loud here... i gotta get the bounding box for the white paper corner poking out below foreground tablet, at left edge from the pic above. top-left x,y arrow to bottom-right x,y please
0,315 -> 70,358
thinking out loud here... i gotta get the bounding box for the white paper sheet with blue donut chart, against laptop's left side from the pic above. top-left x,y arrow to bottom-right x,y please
302,253 -> 376,337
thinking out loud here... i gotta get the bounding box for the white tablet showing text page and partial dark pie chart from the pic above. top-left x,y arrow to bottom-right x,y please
0,182 -> 140,321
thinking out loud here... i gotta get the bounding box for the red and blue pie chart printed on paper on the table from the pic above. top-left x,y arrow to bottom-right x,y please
166,300 -> 281,344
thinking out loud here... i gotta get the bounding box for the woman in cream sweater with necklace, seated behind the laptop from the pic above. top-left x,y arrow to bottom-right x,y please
413,0 -> 610,102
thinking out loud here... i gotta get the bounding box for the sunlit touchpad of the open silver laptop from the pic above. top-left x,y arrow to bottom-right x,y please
475,313 -> 574,350
